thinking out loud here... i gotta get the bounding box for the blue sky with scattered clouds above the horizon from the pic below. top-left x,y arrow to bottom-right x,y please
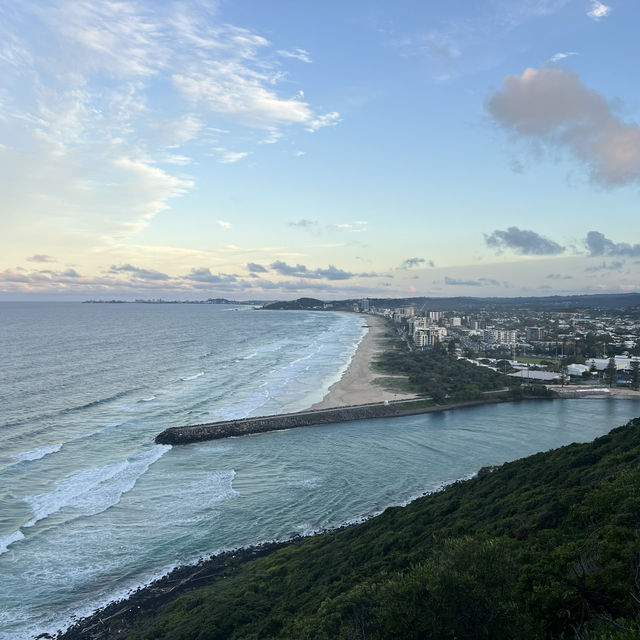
0,0 -> 640,300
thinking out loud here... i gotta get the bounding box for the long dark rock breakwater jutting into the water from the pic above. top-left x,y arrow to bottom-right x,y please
155,392 -> 511,445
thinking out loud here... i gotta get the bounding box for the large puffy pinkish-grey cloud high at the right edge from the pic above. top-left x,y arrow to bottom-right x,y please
486,68 -> 640,186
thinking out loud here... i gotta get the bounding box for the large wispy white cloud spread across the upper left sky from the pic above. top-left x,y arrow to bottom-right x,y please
0,0 -> 339,254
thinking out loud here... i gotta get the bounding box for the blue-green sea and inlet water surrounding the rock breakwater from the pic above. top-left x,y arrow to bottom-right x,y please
0,303 -> 640,640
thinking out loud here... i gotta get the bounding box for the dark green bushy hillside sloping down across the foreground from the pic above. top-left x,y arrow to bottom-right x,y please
110,418 -> 640,640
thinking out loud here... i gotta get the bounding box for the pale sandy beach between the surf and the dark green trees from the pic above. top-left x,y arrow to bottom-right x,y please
311,315 -> 417,409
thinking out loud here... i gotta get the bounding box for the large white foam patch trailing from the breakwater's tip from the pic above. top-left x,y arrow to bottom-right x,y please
24,445 -> 171,527
